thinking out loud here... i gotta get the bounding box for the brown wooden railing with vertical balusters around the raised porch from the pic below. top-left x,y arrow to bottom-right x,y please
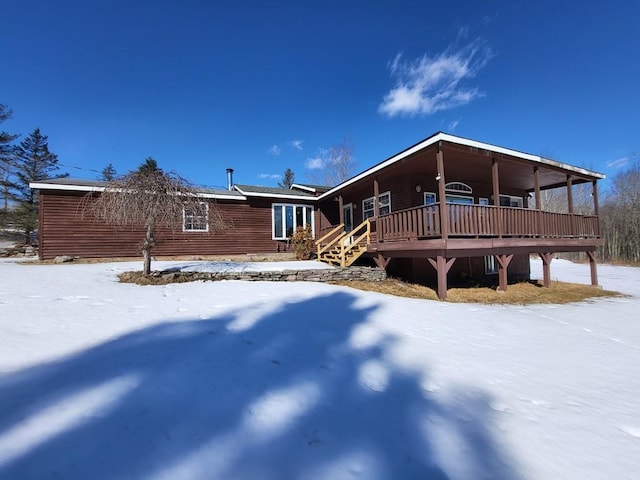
377,204 -> 600,241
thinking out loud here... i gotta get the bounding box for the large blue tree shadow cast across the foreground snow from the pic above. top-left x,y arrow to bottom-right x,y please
0,292 -> 519,480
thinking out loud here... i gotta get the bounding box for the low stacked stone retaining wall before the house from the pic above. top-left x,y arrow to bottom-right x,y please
152,267 -> 387,282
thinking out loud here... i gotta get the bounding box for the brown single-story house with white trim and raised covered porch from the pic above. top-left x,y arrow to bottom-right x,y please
31,132 -> 604,298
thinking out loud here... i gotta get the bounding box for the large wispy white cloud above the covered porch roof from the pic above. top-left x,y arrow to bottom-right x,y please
378,40 -> 493,117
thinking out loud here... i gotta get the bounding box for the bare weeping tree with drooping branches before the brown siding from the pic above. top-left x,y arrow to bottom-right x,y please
82,157 -> 226,275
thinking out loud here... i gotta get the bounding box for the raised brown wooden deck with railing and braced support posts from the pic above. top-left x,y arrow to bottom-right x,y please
366,204 -> 602,299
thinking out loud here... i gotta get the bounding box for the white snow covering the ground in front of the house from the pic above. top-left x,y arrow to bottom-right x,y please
0,260 -> 640,480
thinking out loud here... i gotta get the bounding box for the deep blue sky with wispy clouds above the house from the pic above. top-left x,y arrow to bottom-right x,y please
0,0 -> 640,190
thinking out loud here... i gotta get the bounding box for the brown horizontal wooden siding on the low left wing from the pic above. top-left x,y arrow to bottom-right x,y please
40,190 -> 318,259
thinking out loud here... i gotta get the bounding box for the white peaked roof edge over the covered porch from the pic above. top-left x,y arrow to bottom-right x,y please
317,132 -> 605,200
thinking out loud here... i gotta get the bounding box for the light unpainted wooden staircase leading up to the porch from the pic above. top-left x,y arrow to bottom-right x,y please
316,219 -> 371,267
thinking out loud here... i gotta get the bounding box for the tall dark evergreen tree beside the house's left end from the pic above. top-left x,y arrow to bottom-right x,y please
10,128 -> 68,244
